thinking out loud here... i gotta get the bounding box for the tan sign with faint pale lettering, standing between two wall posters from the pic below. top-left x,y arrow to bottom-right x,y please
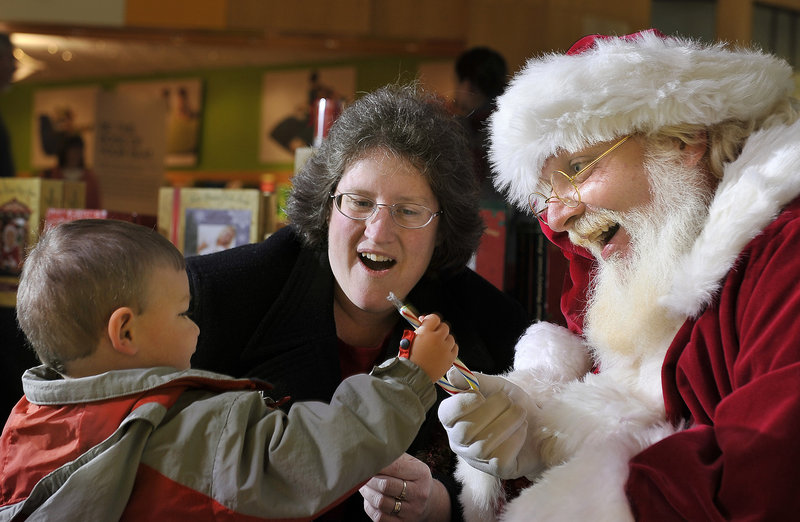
95,92 -> 166,216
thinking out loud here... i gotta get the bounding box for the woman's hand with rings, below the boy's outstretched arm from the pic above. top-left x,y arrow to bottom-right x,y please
359,453 -> 450,522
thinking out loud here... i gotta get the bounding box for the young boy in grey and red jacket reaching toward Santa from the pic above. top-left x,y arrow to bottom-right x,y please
0,220 -> 458,521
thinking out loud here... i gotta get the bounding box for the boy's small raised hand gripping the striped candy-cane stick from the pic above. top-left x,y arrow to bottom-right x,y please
409,314 -> 458,383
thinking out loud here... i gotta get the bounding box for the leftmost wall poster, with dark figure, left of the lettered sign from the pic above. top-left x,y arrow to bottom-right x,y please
31,86 -> 100,170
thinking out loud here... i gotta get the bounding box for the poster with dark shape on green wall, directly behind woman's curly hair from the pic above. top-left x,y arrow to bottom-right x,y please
259,67 -> 356,163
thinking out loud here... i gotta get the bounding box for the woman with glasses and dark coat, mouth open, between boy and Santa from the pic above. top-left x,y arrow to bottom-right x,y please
187,86 -> 527,520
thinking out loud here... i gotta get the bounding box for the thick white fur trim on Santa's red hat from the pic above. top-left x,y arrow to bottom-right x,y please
489,32 -> 794,209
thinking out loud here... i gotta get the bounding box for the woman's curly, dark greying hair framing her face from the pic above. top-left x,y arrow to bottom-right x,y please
287,84 -> 484,272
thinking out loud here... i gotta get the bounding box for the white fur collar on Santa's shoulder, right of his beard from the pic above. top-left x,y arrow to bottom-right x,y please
661,121 -> 800,317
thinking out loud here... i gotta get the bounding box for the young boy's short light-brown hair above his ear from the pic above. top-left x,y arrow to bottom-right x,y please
17,219 -> 186,373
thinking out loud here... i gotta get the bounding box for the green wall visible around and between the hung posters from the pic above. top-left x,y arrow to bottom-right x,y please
0,57 -> 432,172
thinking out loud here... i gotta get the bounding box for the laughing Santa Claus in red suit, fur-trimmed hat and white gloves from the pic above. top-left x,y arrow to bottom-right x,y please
439,30 -> 800,522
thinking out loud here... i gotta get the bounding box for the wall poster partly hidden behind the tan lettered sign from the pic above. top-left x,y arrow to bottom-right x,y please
117,78 -> 203,167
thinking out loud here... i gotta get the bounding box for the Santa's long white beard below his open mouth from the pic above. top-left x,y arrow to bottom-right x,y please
584,148 -> 712,367
